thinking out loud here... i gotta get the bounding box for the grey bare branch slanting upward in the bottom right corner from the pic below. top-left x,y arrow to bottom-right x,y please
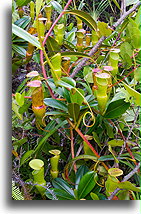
108,163 -> 140,200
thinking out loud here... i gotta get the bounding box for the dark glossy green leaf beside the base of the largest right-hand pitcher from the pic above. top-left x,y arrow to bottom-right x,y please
104,99 -> 130,119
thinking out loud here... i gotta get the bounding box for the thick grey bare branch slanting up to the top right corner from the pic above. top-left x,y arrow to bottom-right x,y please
70,2 -> 141,78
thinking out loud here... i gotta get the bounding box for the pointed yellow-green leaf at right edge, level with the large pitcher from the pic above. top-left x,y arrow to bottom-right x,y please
123,82 -> 141,106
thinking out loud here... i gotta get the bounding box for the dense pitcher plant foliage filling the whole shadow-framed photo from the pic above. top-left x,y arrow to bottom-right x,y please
12,0 -> 141,200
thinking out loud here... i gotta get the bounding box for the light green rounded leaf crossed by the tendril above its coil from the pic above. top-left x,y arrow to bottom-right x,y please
70,88 -> 84,106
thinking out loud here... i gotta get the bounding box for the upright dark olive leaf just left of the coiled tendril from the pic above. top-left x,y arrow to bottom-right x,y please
68,103 -> 80,124
